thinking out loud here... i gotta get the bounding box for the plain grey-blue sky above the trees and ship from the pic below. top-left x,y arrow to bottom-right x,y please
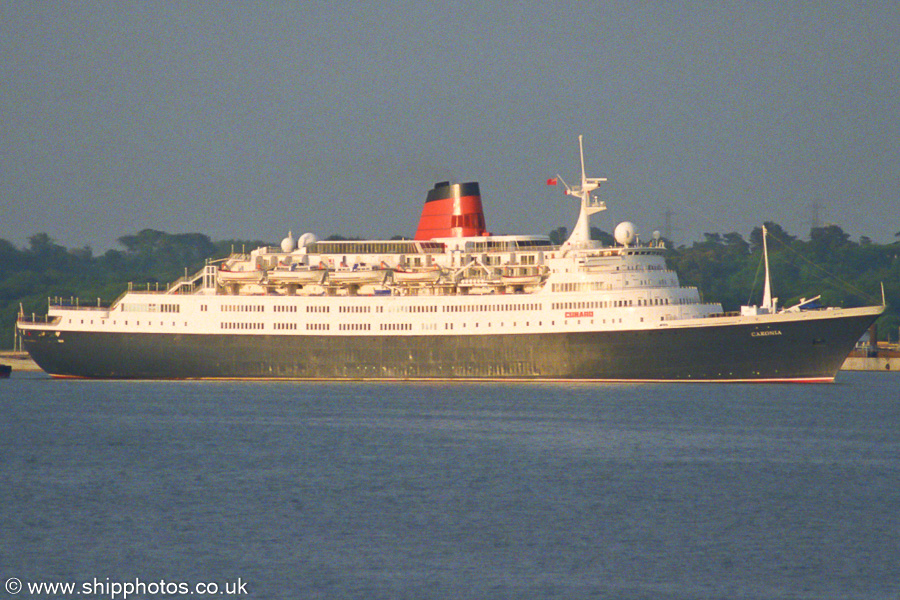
0,0 -> 900,252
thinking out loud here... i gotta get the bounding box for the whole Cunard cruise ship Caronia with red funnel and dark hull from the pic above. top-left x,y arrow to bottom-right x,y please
17,137 -> 884,382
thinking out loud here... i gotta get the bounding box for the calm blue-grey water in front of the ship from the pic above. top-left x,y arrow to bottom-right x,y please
0,373 -> 900,599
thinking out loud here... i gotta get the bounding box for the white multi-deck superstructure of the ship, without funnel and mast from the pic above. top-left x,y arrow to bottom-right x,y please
49,236 -> 722,335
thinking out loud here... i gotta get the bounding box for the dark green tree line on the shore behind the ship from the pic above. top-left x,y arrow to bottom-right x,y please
0,223 -> 900,348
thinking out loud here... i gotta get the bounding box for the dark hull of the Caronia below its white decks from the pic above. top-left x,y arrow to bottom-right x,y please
23,313 -> 878,381
